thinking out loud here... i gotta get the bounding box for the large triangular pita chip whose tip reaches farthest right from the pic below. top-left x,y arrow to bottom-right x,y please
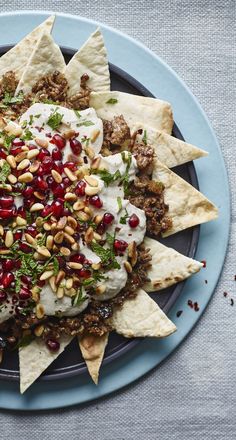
152,160 -> 218,237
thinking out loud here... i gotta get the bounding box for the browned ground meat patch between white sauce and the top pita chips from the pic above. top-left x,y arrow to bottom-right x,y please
0,71 -> 91,120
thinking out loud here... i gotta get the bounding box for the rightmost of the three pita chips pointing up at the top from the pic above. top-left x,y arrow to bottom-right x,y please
64,29 -> 110,96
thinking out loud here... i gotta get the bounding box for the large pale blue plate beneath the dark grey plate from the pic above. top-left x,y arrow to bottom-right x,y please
0,11 -> 230,410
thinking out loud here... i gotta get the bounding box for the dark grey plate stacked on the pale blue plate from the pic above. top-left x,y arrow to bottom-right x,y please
0,46 -> 199,380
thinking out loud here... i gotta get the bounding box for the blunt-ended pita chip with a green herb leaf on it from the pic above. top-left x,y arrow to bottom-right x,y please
90,92 -> 173,134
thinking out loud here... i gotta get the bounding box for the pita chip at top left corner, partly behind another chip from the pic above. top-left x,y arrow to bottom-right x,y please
0,15 -> 55,79
